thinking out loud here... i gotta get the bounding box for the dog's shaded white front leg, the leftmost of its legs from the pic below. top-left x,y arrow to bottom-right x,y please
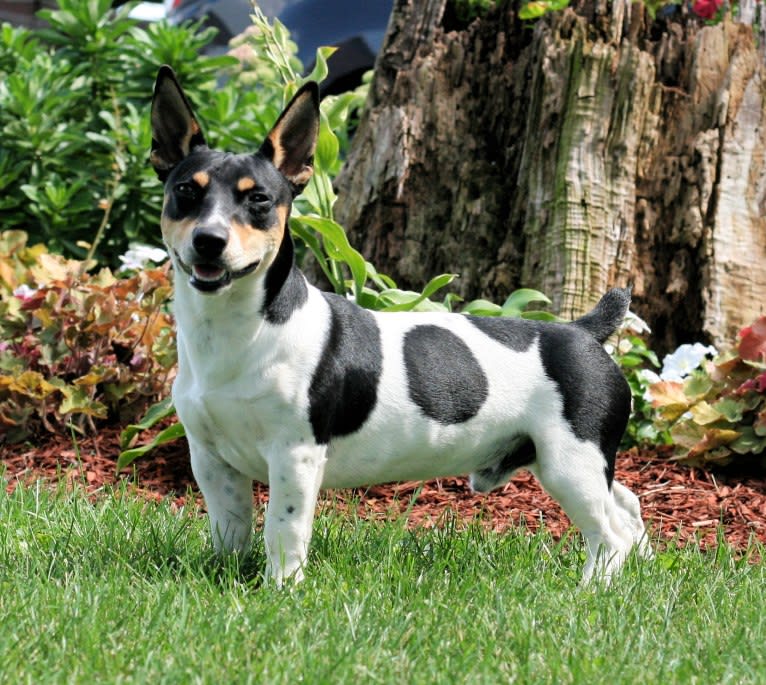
189,439 -> 253,553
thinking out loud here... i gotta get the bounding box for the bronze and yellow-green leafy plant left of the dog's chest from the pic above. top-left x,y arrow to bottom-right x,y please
0,231 -> 175,442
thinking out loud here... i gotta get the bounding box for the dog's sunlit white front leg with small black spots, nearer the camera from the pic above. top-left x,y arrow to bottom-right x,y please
264,443 -> 327,587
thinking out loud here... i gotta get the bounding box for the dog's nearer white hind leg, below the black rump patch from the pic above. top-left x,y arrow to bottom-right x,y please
528,437 -> 633,584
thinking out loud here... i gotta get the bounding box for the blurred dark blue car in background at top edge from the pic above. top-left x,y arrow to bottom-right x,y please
165,0 -> 393,95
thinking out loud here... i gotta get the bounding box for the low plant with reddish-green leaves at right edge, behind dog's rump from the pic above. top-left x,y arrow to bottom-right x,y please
650,317 -> 766,463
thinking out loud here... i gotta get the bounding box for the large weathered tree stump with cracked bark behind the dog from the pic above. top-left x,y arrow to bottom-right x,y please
337,0 -> 766,348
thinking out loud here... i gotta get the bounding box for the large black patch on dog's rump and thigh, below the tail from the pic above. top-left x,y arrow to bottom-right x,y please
539,325 -> 630,484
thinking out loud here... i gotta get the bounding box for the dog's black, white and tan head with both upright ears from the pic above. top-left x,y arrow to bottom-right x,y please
151,66 -> 319,293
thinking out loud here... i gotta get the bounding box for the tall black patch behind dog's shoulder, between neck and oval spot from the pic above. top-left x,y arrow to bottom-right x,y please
307,293 -> 383,444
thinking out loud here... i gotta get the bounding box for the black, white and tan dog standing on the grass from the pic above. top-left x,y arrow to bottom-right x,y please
150,66 -> 648,586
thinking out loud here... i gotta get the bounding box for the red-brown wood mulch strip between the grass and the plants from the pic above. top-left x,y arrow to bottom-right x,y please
0,430 -> 766,549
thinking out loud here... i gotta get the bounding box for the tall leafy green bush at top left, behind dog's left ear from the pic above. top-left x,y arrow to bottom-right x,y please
0,0 -> 282,266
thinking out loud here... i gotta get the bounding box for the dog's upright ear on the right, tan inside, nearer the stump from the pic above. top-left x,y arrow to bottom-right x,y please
260,81 -> 319,195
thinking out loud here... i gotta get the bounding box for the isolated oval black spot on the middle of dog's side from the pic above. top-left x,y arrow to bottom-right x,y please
404,324 -> 489,425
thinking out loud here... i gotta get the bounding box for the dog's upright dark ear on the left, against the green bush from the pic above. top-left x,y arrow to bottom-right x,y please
149,65 -> 205,181
